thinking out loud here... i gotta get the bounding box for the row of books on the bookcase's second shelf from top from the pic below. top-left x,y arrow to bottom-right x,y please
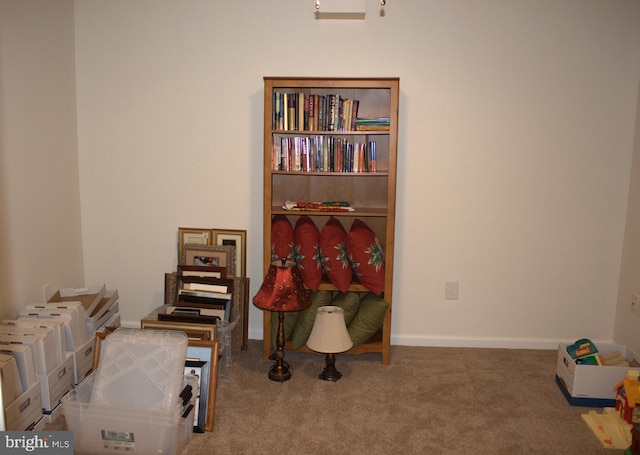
271,135 -> 378,173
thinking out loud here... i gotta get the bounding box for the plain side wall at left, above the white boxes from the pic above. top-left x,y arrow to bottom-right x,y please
0,0 -> 84,319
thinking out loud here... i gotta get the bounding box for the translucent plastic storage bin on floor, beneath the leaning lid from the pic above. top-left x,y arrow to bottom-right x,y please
62,373 -> 194,455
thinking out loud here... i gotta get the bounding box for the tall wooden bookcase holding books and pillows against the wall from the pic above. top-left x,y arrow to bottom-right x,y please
263,77 -> 399,364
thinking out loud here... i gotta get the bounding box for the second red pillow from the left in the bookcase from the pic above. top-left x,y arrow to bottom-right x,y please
292,215 -> 322,292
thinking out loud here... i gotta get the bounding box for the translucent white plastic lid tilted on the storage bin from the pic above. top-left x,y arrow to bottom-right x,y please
90,328 -> 189,411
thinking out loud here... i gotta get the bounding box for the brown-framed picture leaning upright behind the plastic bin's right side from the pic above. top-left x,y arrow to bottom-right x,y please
184,340 -> 218,433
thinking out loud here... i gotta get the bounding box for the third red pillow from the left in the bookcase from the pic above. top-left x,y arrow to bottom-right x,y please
320,216 -> 353,293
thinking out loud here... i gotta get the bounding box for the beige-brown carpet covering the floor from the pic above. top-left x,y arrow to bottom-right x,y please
182,341 -> 623,455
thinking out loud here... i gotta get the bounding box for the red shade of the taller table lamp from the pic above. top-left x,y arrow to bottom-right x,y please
253,260 -> 311,311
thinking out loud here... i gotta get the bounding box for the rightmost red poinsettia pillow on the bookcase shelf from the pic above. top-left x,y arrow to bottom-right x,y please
345,218 -> 384,296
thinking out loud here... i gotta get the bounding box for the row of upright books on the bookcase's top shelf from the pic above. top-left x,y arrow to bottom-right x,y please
272,91 -> 360,131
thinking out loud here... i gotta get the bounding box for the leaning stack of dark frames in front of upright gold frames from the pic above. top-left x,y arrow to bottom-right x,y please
158,267 -> 233,324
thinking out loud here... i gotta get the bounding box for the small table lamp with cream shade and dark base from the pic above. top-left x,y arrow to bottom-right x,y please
307,305 -> 353,382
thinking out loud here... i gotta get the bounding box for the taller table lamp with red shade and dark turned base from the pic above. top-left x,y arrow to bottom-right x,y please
253,258 -> 311,382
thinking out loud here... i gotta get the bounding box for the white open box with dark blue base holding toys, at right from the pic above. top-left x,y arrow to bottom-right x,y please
556,343 -> 640,407
